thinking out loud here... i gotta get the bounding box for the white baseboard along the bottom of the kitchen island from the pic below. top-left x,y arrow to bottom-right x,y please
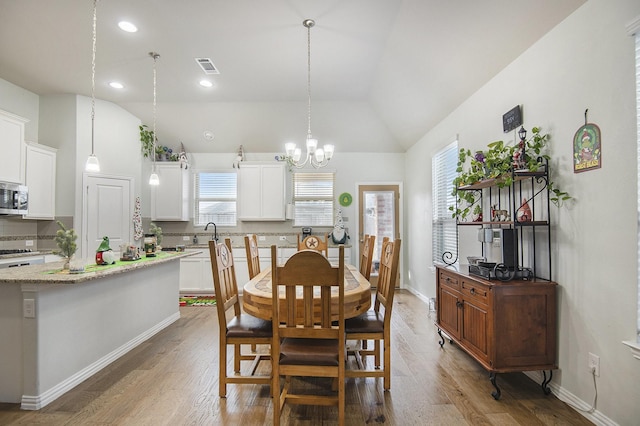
20,312 -> 180,410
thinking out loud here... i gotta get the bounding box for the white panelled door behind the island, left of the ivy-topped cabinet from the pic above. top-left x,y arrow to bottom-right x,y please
82,174 -> 133,262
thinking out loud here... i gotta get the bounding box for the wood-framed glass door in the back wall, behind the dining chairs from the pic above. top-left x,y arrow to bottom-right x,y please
358,185 -> 400,287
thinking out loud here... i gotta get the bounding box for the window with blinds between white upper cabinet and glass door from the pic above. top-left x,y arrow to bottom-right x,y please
293,173 -> 335,226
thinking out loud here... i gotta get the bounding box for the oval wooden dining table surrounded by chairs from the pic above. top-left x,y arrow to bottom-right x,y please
242,265 -> 371,320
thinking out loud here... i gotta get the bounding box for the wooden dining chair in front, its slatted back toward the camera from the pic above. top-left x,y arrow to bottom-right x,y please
271,245 -> 345,425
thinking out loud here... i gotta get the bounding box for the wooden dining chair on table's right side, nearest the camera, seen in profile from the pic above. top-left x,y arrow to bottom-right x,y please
345,238 -> 401,390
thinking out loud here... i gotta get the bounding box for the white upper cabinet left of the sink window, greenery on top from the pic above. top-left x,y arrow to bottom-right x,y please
151,162 -> 189,221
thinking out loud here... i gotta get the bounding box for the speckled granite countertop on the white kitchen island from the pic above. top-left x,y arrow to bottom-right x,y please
0,251 -> 198,285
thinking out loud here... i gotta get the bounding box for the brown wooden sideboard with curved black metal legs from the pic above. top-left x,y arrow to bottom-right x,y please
436,266 -> 557,399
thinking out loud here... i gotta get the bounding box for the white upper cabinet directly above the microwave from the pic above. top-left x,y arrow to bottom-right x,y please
0,110 -> 29,184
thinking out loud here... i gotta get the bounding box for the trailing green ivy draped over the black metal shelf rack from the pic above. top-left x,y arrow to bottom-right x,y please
449,127 -> 571,220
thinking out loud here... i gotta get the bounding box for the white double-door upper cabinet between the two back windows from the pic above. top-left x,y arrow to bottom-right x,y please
238,162 -> 286,221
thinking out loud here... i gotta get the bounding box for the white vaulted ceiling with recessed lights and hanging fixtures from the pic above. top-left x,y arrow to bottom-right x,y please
0,0 -> 586,155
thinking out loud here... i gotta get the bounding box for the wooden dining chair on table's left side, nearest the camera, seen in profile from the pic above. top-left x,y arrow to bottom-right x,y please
209,238 -> 272,398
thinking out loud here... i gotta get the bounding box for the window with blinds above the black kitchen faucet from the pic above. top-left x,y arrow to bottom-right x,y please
194,172 -> 238,226
